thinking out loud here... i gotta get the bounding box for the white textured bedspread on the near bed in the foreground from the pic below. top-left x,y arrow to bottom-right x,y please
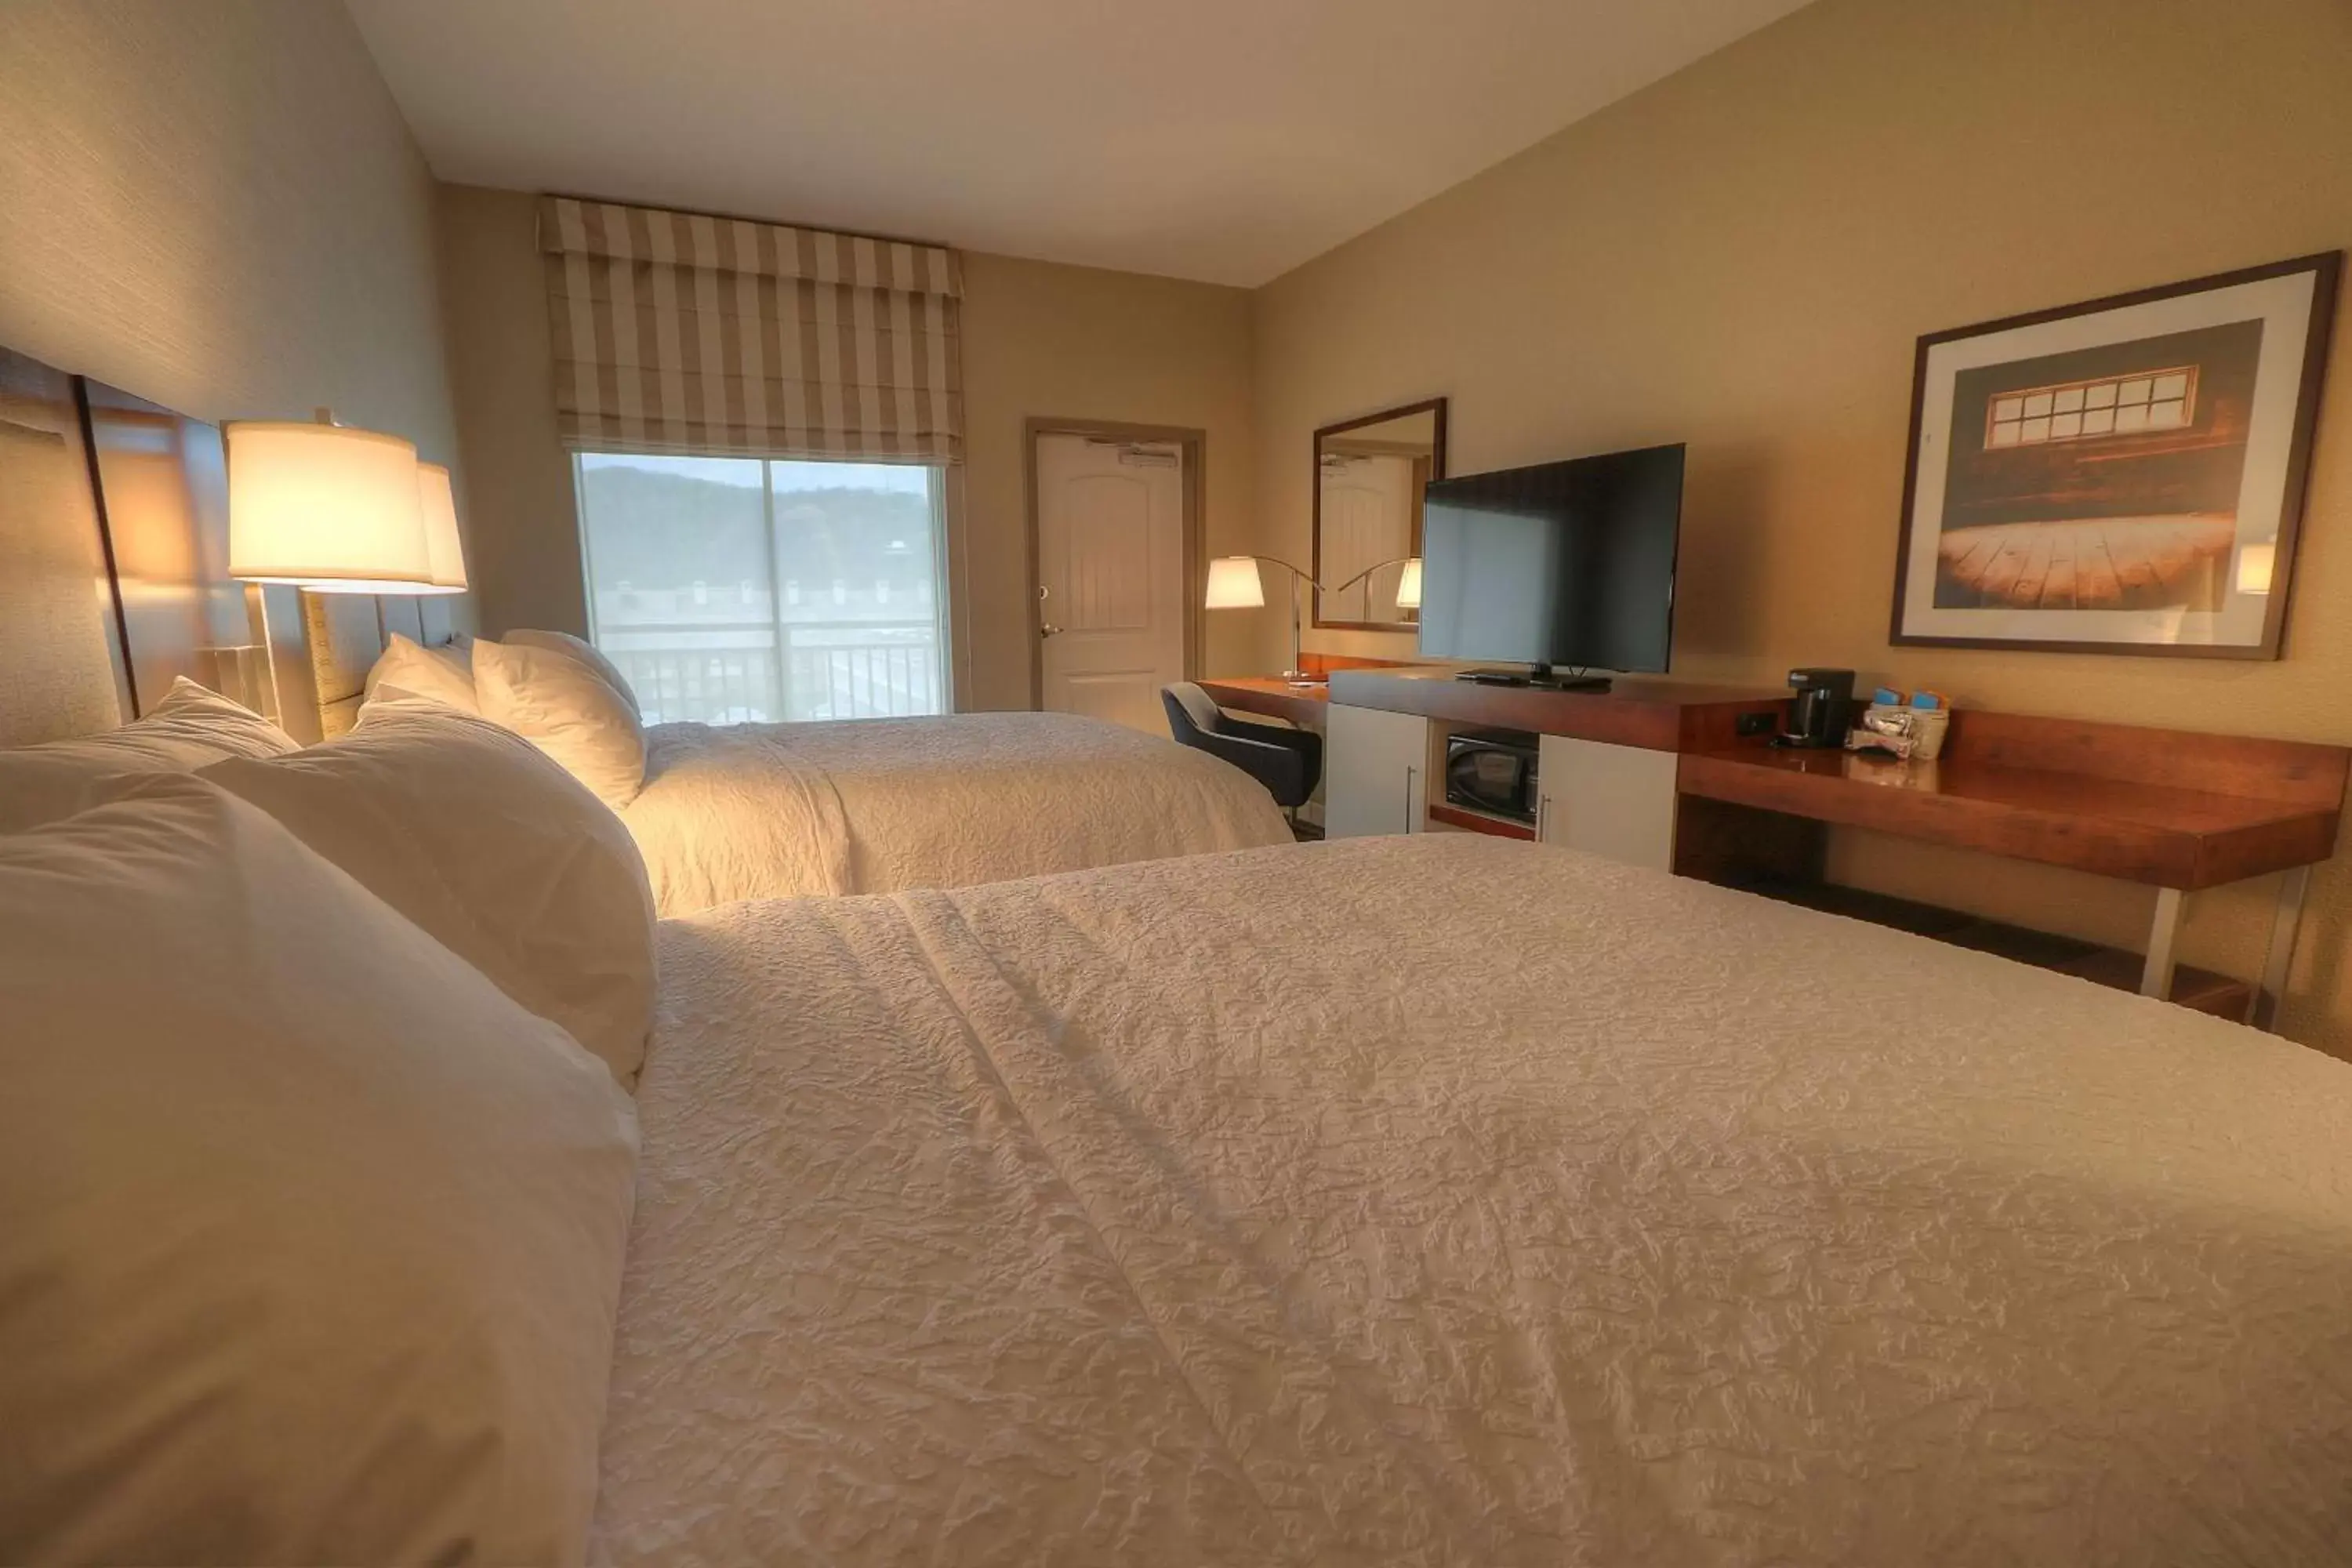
597,837 -> 2352,1568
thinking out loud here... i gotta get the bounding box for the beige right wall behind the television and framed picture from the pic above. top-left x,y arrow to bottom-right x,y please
1254,0 -> 2352,1053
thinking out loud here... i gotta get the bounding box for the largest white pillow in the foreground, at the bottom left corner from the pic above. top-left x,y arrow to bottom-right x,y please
0,776 -> 637,1563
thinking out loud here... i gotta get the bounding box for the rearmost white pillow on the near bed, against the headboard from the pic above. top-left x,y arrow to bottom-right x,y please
0,675 -> 296,832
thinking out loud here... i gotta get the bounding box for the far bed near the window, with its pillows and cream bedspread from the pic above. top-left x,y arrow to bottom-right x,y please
353,616 -> 1291,914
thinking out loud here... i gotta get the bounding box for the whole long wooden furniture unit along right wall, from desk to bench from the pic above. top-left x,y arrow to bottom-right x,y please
1317,668 -> 2352,1027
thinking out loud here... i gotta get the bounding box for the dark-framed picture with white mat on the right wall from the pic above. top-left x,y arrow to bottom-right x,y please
1891,252 -> 2343,659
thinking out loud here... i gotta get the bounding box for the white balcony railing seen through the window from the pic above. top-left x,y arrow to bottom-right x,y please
597,621 -> 946,724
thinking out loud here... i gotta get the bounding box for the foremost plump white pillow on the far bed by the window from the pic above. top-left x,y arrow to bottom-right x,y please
473,633 -> 644,811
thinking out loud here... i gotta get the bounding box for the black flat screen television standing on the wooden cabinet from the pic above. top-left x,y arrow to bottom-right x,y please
1421,445 -> 1682,687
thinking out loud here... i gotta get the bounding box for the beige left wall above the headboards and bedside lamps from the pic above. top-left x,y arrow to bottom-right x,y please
0,0 -> 456,472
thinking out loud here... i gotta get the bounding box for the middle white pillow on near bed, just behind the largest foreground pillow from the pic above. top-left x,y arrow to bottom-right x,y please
202,699 -> 654,1086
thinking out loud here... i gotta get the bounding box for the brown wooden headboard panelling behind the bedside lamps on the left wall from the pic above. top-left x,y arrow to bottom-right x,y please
0,350 -> 473,761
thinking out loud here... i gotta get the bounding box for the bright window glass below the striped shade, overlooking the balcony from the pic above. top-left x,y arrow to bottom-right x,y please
574,452 -> 948,724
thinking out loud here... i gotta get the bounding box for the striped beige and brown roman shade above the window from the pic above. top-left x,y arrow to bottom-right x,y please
539,195 -> 964,463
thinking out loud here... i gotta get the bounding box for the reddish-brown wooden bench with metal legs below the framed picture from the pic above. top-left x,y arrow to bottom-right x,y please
1675,713 -> 2352,1027
